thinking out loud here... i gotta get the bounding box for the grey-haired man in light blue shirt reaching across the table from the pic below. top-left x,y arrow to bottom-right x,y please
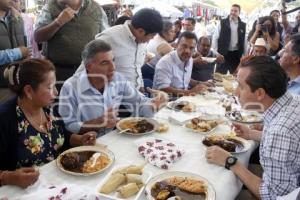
59,39 -> 168,135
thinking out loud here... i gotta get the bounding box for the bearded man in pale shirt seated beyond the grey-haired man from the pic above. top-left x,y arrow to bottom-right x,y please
153,31 -> 204,96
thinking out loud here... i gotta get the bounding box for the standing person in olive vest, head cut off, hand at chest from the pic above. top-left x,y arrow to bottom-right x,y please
34,0 -> 107,88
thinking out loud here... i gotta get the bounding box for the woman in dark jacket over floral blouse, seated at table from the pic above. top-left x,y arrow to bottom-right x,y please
0,59 -> 96,188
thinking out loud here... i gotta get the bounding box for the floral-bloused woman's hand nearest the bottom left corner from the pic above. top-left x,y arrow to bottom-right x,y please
2,167 -> 40,188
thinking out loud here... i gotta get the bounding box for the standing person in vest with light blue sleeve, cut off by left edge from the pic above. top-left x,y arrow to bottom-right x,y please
0,0 -> 30,101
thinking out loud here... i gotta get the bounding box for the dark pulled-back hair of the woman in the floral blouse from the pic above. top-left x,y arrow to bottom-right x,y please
4,58 -> 55,97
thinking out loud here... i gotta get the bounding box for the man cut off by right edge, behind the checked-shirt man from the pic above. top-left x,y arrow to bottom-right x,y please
279,33 -> 300,95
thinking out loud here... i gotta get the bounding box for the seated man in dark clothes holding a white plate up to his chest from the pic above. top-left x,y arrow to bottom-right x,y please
192,36 -> 224,81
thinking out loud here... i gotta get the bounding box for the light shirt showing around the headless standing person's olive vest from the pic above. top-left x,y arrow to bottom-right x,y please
34,0 -> 109,32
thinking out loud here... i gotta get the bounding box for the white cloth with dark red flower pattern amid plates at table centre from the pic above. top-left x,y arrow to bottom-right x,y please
138,139 -> 184,169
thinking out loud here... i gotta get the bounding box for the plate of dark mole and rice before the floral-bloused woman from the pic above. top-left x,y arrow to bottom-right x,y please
56,146 -> 115,176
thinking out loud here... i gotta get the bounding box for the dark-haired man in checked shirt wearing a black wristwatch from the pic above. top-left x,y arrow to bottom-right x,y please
206,56 -> 300,200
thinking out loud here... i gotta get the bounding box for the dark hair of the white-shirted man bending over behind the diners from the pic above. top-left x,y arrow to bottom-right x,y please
131,8 -> 163,35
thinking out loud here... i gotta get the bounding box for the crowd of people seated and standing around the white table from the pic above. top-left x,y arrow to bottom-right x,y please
0,0 -> 300,200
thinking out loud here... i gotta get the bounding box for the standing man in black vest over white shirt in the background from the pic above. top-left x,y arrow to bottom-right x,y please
212,4 -> 246,73
